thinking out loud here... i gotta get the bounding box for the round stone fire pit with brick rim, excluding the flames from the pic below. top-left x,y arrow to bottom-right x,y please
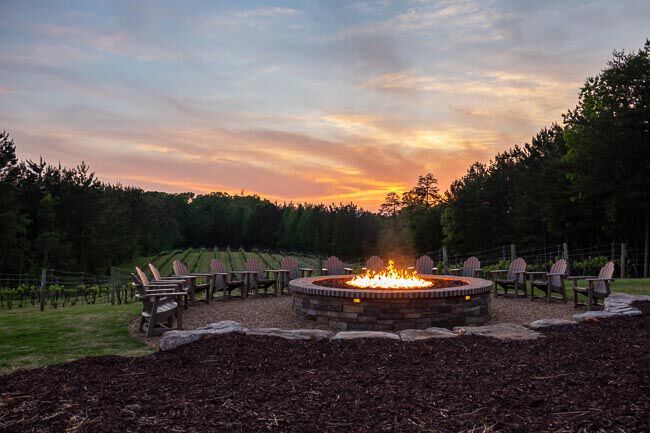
289,276 -> 492,331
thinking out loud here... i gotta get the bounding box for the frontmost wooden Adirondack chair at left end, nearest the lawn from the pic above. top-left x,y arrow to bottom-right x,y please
132,267 -> 187,338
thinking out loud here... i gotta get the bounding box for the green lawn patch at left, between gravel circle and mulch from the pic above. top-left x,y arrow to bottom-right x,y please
0,303 -> 152,374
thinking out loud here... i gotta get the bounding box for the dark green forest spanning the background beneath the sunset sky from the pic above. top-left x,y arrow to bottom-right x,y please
0,41 -> 650,273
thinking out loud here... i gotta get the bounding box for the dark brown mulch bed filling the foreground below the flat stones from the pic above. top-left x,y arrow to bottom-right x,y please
0,303 -> 650,433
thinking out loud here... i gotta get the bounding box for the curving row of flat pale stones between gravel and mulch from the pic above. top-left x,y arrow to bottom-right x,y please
158,293 -> 650,351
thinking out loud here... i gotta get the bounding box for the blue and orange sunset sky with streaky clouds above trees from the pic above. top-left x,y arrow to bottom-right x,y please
0,0 -> 650,210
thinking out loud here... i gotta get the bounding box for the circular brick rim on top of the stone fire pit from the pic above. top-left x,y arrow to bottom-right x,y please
289,275 -> 492,299
